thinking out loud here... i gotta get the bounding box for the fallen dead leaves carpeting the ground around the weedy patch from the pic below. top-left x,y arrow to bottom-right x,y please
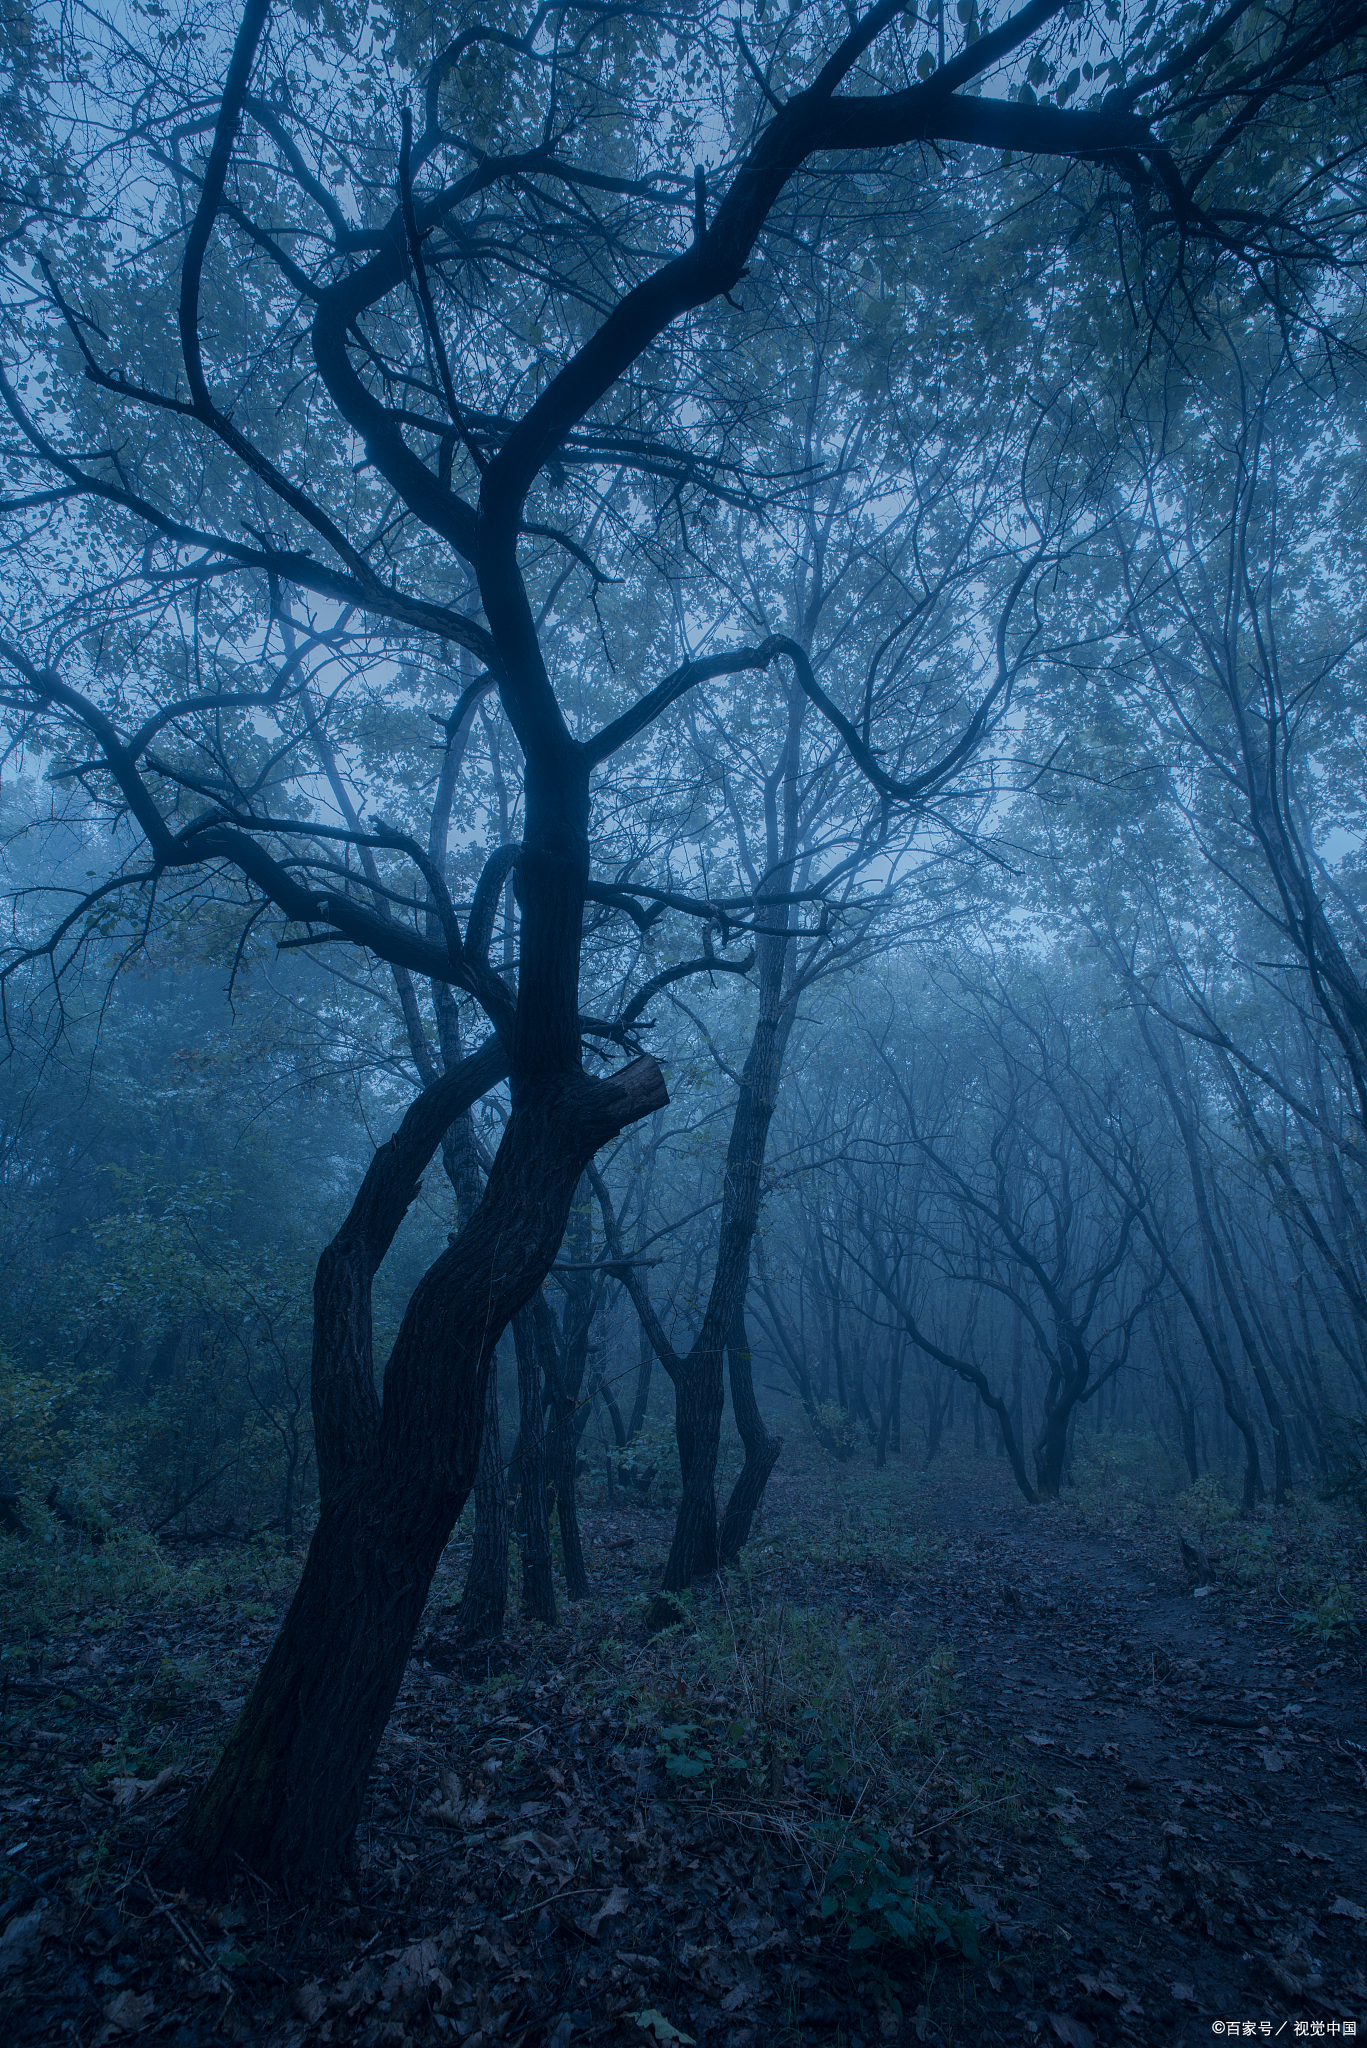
0,1474 -> 1367,2048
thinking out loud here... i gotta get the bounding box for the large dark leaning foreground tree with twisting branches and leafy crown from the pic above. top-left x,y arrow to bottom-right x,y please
0,0 -> 1365,1880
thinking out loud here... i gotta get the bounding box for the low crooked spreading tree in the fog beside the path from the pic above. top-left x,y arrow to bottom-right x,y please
848,958 -> 1152,1501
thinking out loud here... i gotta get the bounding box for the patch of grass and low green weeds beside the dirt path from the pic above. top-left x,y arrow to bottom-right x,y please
545,1581 -> 1014,1968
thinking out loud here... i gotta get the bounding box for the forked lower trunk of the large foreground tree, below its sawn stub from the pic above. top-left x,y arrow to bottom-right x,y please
184,1055 -> 668,1884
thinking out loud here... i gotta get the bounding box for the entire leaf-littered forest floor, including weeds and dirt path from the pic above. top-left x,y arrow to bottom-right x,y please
0,1442 -> 1367,2048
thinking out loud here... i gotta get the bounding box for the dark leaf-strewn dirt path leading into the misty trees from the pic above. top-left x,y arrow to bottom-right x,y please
926,1487 -> 1367,2044
